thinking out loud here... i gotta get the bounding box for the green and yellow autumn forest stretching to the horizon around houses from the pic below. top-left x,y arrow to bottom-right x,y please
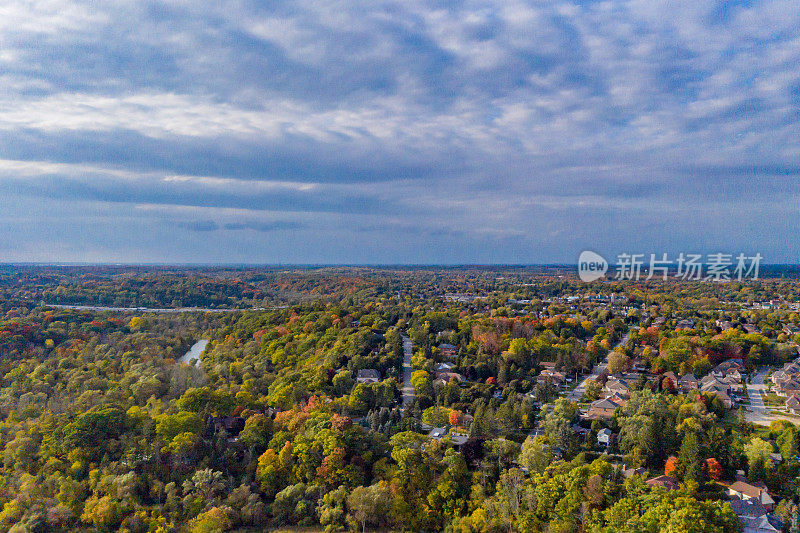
0,266 -> 800,533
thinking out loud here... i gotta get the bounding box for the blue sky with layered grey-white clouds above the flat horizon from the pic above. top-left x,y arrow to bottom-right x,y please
0,0 -> 800,264
